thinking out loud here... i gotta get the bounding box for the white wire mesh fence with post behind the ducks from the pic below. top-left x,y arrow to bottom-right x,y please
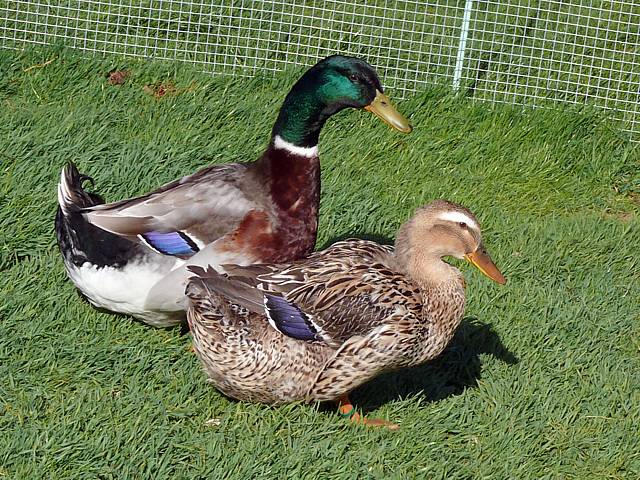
0,0 -> 640,138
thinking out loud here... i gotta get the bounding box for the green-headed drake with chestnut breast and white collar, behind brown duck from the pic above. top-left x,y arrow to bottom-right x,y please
55,55 -> 411,326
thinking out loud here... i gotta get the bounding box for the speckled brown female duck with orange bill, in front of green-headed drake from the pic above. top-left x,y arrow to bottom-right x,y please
187,200 -> 505,426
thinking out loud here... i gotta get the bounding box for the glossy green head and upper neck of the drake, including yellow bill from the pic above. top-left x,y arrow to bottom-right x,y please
273,55 -> 411,147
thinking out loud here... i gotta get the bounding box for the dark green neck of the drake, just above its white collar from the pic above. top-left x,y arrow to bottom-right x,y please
272,82 -> 344,148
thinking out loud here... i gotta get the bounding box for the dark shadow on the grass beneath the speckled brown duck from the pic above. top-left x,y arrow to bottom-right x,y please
338,317 -> 519,414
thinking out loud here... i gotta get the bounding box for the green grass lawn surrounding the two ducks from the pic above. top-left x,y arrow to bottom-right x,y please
0,49 -> 640,479
